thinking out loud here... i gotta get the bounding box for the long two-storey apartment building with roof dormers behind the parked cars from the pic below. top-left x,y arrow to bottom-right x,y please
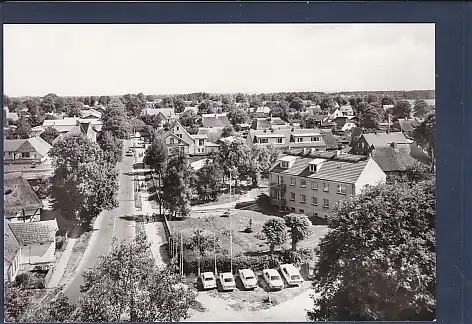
269,152 -> 386,218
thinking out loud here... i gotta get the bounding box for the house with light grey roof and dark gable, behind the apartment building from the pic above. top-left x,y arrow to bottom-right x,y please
350,132 -> 411,155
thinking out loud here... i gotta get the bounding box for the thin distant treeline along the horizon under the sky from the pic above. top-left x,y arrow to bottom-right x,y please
8,90 -> 436,105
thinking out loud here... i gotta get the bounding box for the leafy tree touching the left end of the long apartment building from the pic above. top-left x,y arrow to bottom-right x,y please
250,144 -> 280,187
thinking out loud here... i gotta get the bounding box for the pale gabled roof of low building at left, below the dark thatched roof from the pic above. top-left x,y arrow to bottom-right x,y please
9,219 -> 59,245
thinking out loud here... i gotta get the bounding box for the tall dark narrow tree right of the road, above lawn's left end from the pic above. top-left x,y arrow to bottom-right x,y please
162,154 -> 193,218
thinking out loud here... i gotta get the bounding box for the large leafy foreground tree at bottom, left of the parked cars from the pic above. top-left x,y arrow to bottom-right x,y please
76,232 -> 196,322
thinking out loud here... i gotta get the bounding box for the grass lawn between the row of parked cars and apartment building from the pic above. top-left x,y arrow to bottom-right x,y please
169,210 -> 328,254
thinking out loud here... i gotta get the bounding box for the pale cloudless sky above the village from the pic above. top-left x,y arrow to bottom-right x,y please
3,24 -> 435,96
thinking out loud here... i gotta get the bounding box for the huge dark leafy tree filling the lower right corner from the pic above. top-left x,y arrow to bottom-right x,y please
308,181 -> 436,321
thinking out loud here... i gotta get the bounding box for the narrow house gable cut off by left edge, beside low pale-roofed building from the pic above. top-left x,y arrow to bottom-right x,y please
3,218 -> 21,282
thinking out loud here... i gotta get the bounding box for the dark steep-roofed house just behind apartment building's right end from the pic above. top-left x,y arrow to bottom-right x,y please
370,142 -> 431,176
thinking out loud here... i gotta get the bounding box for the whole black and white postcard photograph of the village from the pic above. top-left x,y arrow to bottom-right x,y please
2,23 -> 436,322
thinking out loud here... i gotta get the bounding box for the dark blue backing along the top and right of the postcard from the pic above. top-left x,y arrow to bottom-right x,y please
0,2 -> 472,323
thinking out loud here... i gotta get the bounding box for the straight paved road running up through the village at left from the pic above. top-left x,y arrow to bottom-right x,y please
64,141 -> 136,302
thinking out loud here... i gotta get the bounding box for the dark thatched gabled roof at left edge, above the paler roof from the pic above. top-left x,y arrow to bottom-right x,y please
3,173 -> 43,218
